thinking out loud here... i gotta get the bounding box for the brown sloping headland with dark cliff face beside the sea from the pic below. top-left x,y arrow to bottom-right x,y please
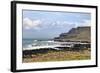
54,26 -> 91,42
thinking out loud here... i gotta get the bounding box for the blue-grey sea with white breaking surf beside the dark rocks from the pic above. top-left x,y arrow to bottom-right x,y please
22,39 -> 79,50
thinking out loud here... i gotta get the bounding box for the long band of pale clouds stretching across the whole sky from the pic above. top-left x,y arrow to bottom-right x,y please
23,18 -> 91,30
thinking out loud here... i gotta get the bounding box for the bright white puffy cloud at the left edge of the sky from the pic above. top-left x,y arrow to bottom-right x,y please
23,18 -> 42,30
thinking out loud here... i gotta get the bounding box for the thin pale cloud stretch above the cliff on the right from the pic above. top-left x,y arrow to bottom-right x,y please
51,20 -> 91,29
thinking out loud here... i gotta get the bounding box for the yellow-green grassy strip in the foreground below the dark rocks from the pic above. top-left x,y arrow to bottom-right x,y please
23,49 -> 91,63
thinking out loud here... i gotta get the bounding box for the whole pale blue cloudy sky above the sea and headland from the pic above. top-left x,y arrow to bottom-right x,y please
23,10 -> 91,39
